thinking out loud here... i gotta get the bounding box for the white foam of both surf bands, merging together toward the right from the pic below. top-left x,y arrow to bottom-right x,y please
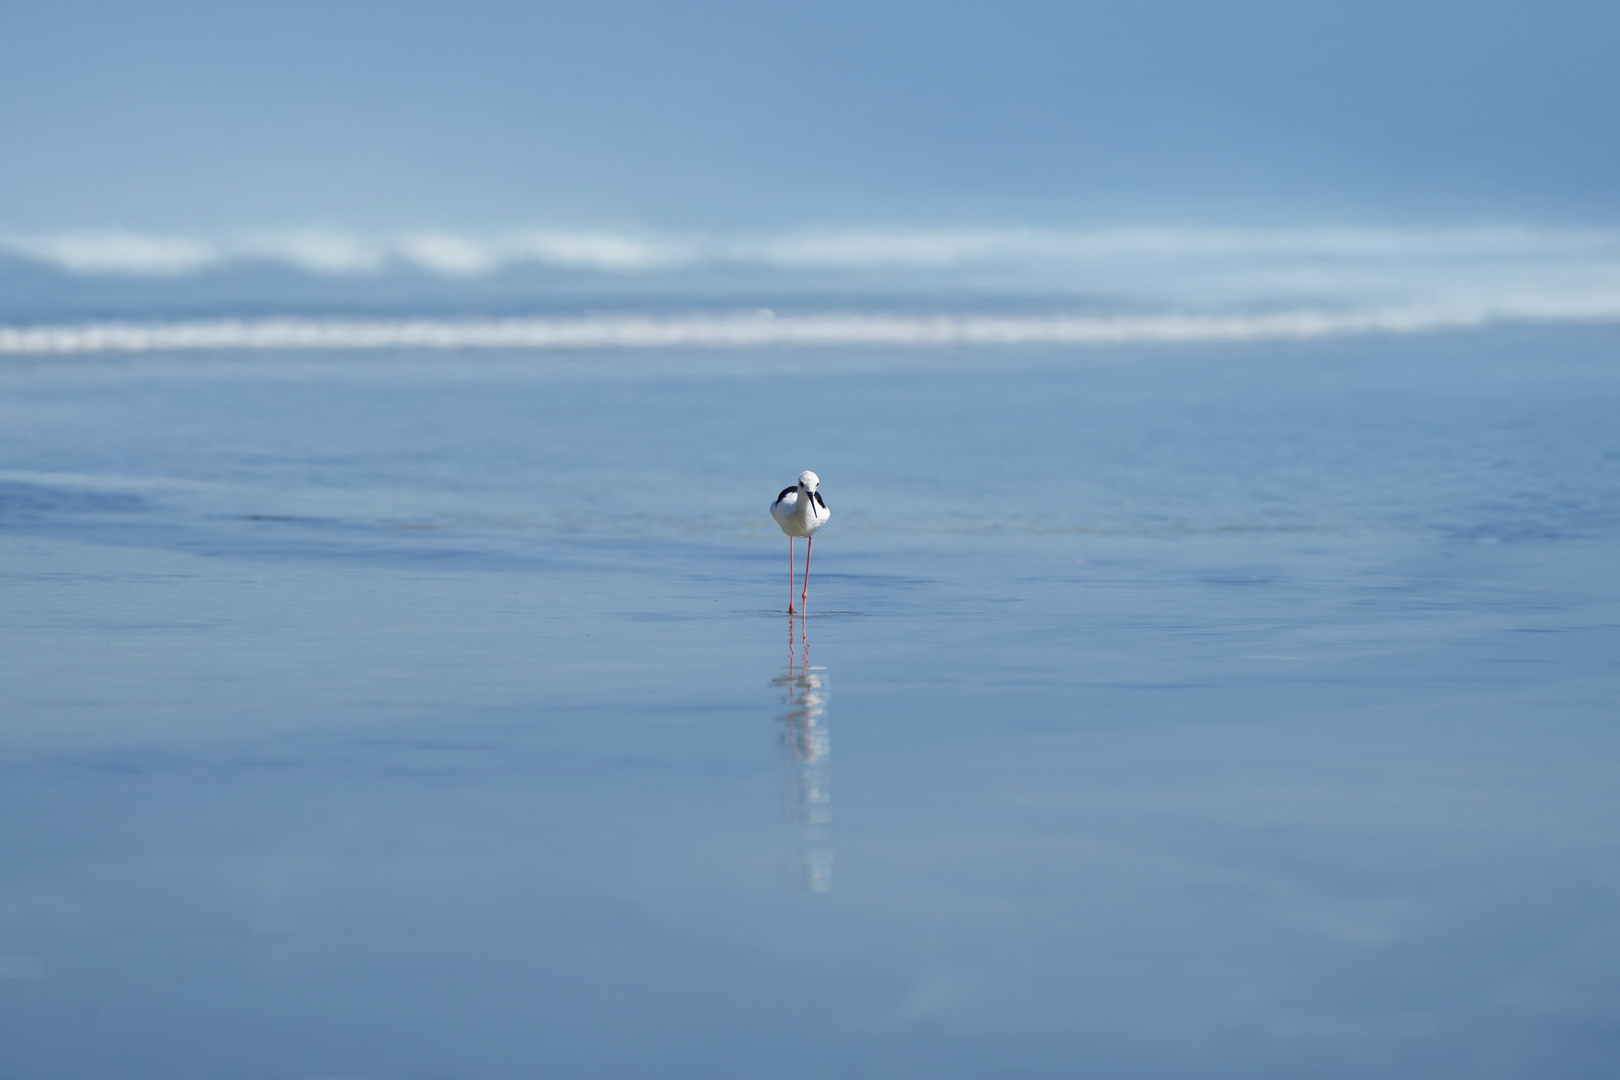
0,228 -> 1620,355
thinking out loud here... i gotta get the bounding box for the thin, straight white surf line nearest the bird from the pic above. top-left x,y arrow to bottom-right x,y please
0,293 -> 1620,356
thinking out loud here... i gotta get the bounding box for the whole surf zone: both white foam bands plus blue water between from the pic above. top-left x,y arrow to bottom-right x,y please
12,228 -> 1620,355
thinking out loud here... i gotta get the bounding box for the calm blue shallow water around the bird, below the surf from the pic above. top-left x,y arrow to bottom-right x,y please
0,329 -> 1620,1080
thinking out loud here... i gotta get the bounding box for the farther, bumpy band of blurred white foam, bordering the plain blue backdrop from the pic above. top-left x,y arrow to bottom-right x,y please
9,227 -> 1620,275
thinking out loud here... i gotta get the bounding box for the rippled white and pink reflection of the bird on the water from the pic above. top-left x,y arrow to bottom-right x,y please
771,615 -> 833,892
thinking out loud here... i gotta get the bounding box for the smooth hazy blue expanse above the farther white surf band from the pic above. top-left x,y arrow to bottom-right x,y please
0,0 -> 1620,233
